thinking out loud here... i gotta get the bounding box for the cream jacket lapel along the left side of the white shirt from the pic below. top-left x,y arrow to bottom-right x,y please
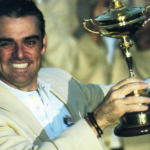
0,84 -> 49,141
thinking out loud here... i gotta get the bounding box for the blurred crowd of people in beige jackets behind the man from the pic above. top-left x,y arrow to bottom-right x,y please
36,0 -> 150,150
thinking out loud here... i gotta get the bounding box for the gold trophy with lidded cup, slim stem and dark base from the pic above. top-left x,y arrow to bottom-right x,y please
83,0 -> 150,137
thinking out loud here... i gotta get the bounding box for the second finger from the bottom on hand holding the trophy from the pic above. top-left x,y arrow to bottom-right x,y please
121,96 -> 150,105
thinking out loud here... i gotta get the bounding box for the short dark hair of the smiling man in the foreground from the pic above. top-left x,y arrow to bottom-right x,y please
0,0 -> 45,38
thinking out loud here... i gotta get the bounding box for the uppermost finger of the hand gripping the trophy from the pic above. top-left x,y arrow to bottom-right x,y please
113,77 -> 144,90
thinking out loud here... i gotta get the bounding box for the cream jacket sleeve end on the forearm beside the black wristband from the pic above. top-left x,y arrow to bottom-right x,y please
54,119 -> 104,150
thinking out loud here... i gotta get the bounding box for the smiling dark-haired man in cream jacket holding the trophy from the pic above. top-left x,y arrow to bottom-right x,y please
0,0 -> 150,150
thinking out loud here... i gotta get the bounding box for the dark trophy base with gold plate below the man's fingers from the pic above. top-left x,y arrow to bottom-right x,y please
114,88 -> 150,137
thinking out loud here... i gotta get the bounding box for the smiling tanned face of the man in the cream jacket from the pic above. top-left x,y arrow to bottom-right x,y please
0,16 -> 46,91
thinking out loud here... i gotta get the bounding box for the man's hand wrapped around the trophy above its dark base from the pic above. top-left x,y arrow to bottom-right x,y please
86,78 -> 150,137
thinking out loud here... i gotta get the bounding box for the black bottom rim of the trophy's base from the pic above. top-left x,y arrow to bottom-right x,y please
114,124 -> 150,137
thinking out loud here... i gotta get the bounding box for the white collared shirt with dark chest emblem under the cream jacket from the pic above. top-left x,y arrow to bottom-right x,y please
0,79 -> 73,140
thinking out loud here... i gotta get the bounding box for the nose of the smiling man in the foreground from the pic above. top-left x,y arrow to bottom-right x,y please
13,45 -> 25,60
